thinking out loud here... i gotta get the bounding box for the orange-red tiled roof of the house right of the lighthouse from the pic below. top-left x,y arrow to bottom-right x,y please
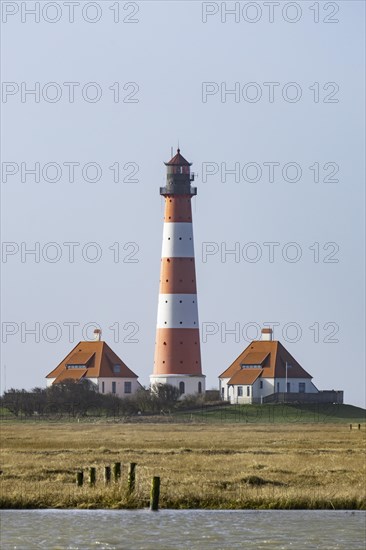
220,340 -> 312,379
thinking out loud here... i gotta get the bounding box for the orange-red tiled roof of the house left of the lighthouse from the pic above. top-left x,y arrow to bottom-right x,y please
46,341 -> 138,381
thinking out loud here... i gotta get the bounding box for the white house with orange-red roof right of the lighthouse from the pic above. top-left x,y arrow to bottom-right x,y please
219,328 -> 322,404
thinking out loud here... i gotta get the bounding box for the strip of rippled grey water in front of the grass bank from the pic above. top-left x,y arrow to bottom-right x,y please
0,510 -> 366,550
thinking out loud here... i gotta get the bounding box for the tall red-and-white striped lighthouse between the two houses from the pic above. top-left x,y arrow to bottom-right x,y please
150,148 -> 205,396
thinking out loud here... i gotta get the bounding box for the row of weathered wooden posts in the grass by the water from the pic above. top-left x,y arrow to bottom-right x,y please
76,462 -> 160,511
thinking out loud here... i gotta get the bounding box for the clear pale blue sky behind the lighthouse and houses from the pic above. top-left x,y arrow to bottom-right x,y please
0,0 -> 365,406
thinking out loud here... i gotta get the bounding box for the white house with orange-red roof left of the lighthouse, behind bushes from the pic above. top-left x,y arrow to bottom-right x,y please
46,330 -> 142,397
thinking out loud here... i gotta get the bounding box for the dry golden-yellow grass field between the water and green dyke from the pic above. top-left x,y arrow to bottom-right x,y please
0,420 -> 366,509
